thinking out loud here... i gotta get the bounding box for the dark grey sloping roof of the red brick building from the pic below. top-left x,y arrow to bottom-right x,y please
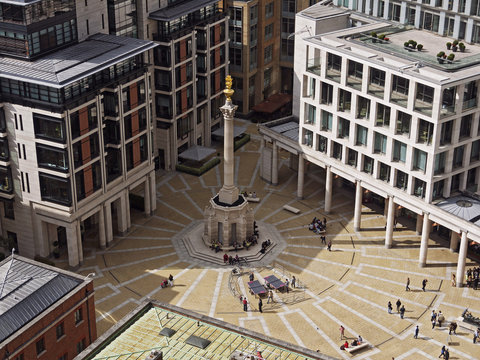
0,255 -> 85,343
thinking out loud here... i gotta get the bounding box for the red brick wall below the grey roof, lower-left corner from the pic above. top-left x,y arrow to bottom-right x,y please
0,283 -> 97,360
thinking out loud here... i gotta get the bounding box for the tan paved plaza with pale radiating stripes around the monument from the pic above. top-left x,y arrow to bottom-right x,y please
60,119 -> 480,360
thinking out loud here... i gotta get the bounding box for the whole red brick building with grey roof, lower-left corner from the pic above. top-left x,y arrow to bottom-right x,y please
0,255 -> 97,360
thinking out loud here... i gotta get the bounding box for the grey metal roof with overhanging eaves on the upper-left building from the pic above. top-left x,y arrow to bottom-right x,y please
0,34 -> 157,88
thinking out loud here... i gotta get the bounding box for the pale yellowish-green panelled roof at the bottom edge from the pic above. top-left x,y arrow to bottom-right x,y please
79,301 -> 334,360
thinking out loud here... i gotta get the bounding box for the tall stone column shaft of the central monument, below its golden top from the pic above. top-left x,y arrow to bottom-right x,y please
218,96 -> 239,205
